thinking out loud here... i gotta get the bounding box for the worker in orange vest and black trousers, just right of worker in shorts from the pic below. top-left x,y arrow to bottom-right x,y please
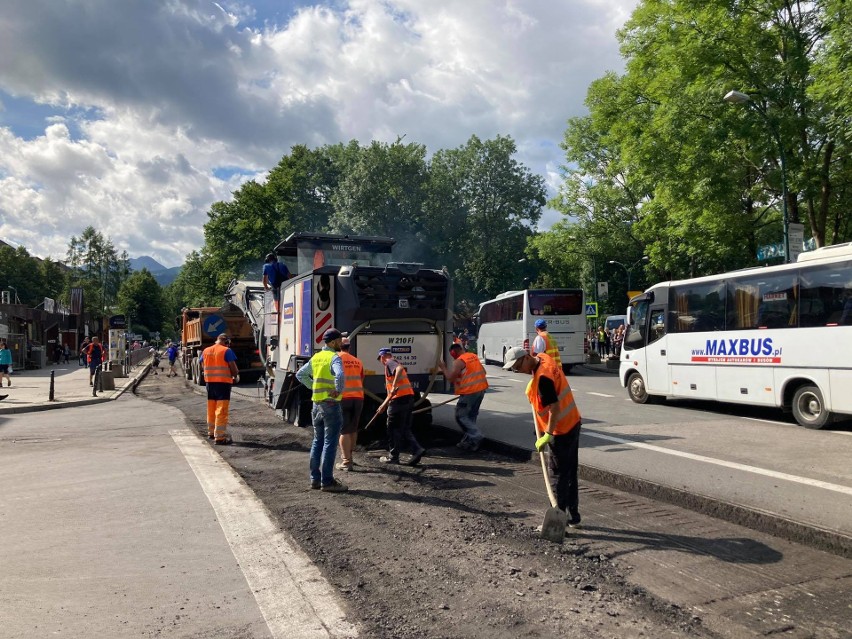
377,348 -> 426,466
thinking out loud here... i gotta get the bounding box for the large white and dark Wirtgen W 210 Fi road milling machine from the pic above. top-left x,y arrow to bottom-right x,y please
266,233 -> 453,426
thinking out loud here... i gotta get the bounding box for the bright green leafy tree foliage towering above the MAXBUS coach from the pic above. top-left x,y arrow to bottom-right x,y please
553,0 -> 852,281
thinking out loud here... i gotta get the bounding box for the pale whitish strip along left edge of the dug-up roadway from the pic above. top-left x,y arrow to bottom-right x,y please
169,430 -> 358,639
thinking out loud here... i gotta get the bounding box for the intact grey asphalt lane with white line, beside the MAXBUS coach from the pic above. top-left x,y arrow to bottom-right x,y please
432,366 -> 852,552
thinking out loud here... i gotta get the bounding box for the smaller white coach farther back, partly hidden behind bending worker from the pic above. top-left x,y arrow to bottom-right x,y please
476,288 -> 586,371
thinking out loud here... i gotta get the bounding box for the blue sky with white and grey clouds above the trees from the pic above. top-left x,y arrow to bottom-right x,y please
0,0 -> 638,267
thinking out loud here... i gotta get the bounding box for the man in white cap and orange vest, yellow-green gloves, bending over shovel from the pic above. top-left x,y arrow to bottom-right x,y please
503,346 -> 581,527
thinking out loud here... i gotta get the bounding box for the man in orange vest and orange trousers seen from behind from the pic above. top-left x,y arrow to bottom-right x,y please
198,333 -> 240,446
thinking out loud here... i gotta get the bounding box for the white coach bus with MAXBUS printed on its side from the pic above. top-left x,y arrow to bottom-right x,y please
619,243 -> 852,428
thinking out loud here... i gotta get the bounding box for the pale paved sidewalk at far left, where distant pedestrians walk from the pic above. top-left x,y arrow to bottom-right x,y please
0,360 -> 150,415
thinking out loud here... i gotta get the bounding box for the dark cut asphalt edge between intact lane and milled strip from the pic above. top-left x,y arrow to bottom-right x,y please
452,426 -> 852,559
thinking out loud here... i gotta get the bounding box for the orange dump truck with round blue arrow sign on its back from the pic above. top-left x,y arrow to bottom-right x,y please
181,304 -> 263,385
